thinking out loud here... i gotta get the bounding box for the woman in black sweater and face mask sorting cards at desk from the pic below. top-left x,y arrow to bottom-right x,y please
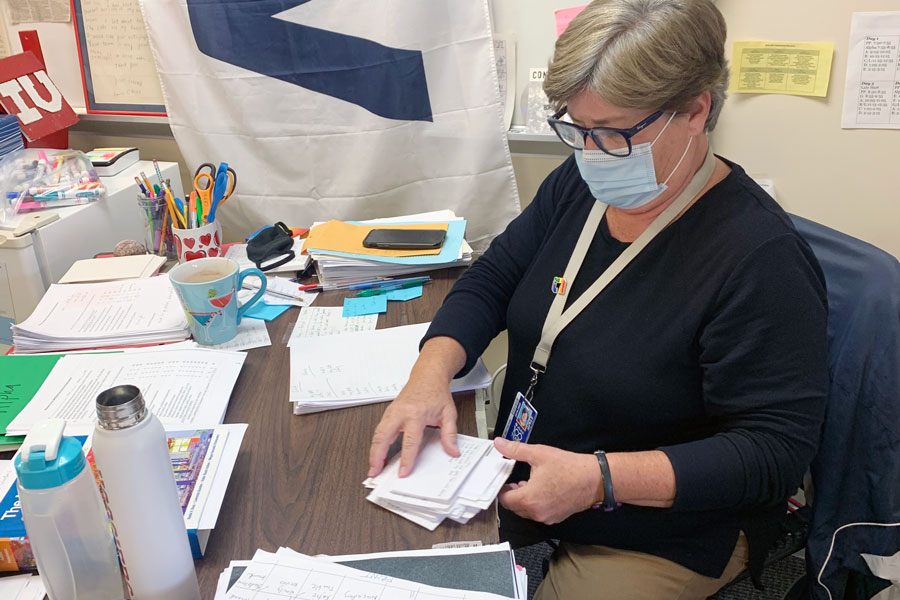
370,0 -> 826,600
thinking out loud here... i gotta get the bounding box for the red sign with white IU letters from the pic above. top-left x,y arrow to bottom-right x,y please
0,52 -> 78,142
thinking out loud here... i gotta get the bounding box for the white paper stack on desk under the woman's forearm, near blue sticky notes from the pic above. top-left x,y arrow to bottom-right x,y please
290,322 -> 491,415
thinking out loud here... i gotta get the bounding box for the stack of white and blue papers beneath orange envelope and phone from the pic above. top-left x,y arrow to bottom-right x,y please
305,210 -> 472,289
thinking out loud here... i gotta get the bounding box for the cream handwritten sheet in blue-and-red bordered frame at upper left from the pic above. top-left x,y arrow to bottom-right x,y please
72,0 -> 166,114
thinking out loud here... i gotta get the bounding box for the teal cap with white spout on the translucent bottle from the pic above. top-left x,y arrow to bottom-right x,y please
15,419 -> 85,490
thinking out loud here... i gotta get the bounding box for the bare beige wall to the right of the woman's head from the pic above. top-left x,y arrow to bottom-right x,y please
713,0 -> 900,257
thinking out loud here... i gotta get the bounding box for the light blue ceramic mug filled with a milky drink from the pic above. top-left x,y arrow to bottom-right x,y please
169,258 -> 266,345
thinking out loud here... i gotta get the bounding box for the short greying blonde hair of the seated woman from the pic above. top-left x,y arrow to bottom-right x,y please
544,0 -> 728,131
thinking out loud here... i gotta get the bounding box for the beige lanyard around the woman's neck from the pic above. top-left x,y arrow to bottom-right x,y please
525,148 -> 715,401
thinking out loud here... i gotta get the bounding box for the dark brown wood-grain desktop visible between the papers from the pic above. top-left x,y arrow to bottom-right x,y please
195,269 -> 498,598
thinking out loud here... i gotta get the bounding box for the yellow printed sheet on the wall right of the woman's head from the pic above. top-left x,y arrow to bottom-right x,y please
729,42 -> 834,98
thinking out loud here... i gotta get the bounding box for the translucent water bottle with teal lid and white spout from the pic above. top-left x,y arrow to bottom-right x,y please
15,419 -> 123,600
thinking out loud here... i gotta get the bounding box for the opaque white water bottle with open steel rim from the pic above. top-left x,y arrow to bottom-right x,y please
92,385 -> 200,600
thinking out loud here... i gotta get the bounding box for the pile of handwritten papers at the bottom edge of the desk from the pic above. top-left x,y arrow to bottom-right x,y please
214,544 -> 526,600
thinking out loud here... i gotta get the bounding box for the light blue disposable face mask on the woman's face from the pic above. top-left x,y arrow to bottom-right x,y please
575,113 -> 694,209
